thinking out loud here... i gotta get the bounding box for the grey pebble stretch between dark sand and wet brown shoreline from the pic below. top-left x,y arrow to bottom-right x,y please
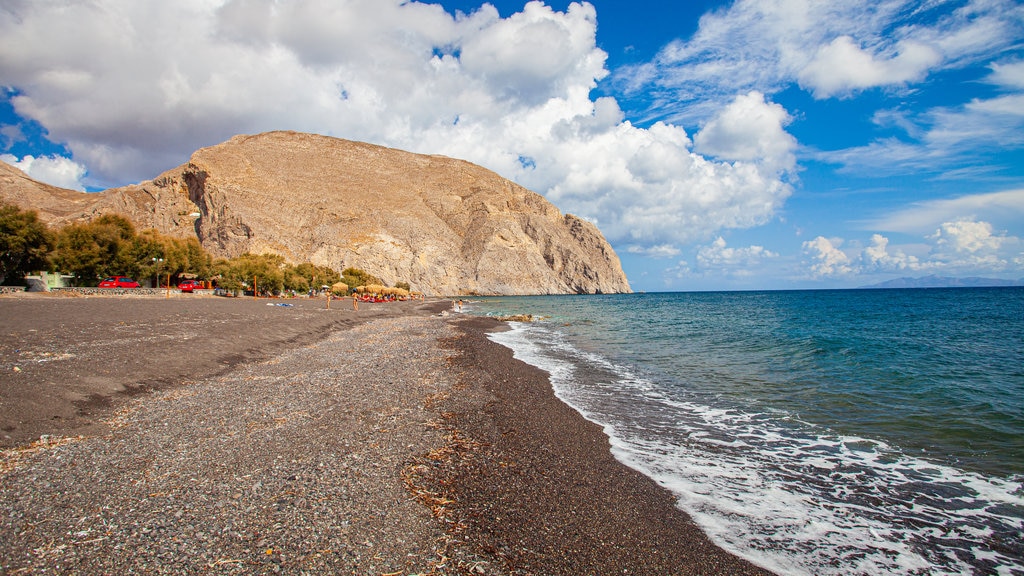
0,316 -> 483,574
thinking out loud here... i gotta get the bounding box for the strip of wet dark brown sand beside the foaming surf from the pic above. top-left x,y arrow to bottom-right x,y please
438,317 -> 771,575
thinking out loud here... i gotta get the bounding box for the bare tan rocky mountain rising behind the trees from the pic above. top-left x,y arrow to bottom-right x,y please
0,132 -> 630,295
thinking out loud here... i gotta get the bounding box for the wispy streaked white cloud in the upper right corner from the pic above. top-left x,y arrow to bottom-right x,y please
615,0 -> 1022,125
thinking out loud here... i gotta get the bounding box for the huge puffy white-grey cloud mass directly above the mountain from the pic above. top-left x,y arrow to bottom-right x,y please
0,0 -> 796,255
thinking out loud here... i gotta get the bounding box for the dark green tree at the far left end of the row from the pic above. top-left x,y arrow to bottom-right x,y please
0,204 -> 53,284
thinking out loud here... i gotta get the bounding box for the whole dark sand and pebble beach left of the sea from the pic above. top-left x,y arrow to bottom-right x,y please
0,294 -> 764,574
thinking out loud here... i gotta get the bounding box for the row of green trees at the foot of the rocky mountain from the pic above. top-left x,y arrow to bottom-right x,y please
0,204 -> 391,293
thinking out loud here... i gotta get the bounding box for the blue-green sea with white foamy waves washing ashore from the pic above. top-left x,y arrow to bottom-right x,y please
464,288 -> 1024,575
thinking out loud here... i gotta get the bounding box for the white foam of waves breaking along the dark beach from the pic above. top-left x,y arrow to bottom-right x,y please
490,323 -> 1024,574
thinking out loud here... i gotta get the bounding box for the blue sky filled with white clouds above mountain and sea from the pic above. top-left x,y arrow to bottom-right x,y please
0,0 -> 1024,291
